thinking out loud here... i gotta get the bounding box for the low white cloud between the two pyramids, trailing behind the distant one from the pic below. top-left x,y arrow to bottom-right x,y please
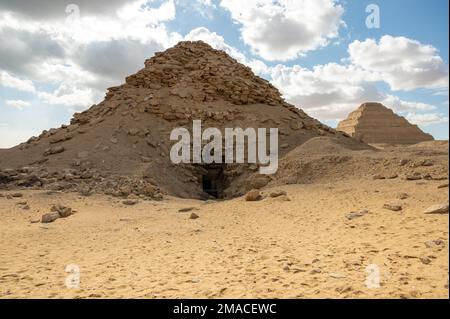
271,63 -> 436,120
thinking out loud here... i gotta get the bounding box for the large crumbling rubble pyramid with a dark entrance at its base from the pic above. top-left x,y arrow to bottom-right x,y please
0,42 -> 357,199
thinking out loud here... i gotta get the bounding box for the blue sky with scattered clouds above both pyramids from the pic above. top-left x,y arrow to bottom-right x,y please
0,0 -> 449,147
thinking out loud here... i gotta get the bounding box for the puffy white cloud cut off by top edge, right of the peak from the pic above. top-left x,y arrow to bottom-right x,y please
220,0 -> 344,61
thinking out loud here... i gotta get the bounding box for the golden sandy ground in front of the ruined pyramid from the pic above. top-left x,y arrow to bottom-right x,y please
0,179 -> 449,298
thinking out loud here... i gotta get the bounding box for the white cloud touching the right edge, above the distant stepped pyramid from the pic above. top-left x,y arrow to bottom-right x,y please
348,35 -> 448,91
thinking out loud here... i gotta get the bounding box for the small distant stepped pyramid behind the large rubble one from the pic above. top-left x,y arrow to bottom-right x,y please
337,103 -> 433,144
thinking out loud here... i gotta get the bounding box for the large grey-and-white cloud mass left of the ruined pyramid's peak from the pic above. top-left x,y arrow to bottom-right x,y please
0,0 -> 181,108
